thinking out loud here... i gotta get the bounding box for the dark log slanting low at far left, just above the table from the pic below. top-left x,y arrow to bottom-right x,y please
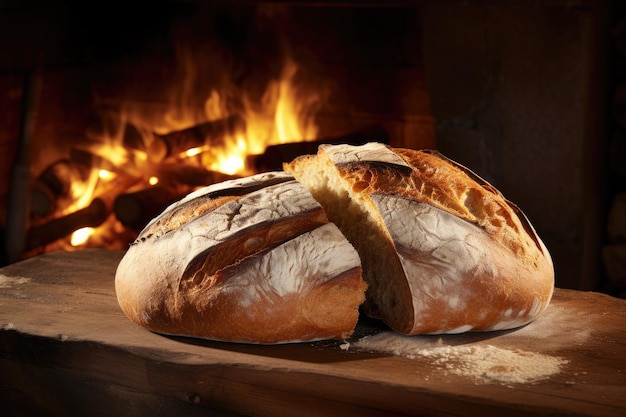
25,198 -> 109,251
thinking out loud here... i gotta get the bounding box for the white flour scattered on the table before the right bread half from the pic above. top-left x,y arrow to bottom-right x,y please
352,332 -> 568,384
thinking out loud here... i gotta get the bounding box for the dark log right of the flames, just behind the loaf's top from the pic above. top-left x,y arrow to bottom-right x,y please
247,126 -> 389,172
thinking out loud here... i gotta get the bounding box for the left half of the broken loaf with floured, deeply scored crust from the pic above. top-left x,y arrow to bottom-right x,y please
115,172 -> 367,343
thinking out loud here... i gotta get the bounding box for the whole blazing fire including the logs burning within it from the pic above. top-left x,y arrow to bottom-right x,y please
37,55 -> 321,254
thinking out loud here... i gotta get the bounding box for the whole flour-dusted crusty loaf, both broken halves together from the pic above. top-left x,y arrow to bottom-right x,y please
115,143 -> 554,343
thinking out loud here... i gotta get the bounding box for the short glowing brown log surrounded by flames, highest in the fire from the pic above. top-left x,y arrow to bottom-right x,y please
148,115 -> 245,161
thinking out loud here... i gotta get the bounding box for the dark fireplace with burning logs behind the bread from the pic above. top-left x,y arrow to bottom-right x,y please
0,0 -> 619,291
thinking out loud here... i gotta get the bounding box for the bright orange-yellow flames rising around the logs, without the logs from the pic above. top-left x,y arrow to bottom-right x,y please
46,54 -> 321,252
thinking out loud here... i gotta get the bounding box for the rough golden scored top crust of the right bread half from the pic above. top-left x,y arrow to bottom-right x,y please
321,143 -> 546,262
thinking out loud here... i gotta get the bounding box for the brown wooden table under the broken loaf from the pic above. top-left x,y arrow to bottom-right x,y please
0,250 -> 626,417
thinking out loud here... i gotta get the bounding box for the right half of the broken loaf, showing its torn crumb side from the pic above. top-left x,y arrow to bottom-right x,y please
284,143 -> 554,334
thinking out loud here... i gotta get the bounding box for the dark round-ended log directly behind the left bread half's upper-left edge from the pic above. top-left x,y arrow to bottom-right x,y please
113,185 -> 192,232
